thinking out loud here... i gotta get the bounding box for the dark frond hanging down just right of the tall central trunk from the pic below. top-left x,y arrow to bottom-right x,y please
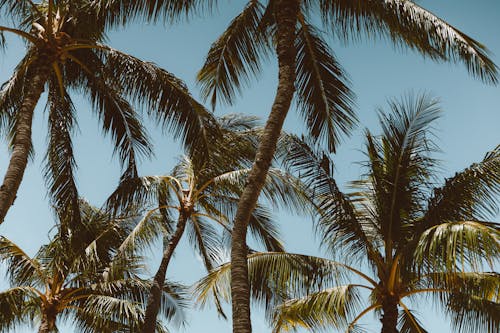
296,18 -> 357,152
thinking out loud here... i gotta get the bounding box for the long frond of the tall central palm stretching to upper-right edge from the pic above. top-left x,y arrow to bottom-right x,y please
320,0 -> 498,83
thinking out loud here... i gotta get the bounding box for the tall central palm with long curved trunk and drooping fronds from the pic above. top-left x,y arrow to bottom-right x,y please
193,0 -> 497,333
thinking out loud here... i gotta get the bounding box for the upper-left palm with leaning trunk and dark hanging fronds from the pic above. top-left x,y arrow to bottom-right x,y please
0,0 -> 215,223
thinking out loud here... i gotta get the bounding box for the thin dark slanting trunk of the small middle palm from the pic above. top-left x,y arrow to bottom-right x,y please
143,213 -> 188,333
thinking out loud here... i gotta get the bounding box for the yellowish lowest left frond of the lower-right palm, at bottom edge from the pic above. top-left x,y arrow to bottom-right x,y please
273,284 -> 361,332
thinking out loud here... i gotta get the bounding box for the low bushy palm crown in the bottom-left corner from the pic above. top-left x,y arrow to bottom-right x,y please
0,201 -> 185,333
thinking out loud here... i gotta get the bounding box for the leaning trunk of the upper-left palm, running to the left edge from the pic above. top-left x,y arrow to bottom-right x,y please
0,65 -> 49,224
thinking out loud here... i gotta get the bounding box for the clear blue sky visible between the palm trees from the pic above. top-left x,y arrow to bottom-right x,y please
0,0 -> 500,333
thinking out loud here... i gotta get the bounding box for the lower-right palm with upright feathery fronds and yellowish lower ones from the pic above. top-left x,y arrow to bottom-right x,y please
194,96 -> 500,333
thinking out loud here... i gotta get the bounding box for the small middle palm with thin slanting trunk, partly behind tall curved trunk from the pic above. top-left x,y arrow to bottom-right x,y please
109,115 -> 307,333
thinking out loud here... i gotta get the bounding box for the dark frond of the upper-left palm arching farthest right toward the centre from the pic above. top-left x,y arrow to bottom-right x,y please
103,49 -> 218,157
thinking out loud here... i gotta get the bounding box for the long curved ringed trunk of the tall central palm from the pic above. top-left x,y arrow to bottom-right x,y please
231,0 -> 299,333
